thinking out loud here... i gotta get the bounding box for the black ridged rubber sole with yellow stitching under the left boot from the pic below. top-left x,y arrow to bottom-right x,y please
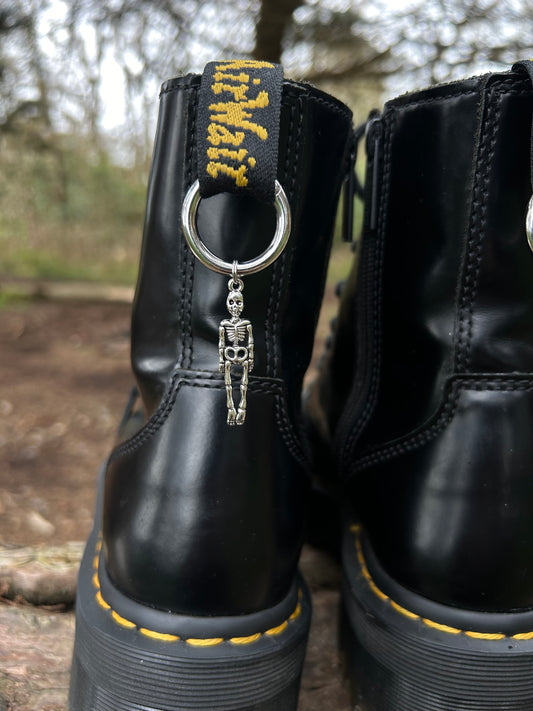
69,468 -> 311,711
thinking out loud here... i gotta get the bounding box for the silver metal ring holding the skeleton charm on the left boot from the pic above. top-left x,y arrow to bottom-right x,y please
181,180 -> 291,276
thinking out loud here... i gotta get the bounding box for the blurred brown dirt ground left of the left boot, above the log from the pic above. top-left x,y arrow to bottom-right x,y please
0,302 -> 132,544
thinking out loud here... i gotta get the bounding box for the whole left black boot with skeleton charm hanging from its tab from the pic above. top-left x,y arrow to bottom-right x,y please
70,62 -> 351,711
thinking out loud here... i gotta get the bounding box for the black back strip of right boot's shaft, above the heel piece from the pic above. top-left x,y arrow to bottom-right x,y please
464,81 -> 533,373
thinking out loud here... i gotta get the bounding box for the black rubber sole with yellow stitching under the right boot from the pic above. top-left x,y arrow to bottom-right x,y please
340,526 -> 533,711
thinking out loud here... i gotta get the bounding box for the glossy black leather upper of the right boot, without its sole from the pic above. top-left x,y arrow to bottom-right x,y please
308,73 -> 533,611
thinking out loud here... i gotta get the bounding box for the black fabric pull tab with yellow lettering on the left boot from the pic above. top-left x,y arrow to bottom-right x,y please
196,59 -> 283,204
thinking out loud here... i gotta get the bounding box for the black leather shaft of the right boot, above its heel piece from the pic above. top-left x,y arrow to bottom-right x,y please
340,68 -> 533,451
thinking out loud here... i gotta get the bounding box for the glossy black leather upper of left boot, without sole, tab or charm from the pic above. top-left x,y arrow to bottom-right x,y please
103,77 -> 351,615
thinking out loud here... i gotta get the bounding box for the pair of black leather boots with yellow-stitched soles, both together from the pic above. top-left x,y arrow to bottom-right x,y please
70,61 -> 533,711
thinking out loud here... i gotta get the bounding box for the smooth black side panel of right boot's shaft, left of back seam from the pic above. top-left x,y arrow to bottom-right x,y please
349,83 -> 480,456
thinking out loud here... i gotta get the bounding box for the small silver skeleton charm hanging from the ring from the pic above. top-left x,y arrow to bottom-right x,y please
218,276 -> 254,425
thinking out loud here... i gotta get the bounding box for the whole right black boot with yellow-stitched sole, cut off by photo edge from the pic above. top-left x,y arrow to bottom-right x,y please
308,63 -> 533,711
